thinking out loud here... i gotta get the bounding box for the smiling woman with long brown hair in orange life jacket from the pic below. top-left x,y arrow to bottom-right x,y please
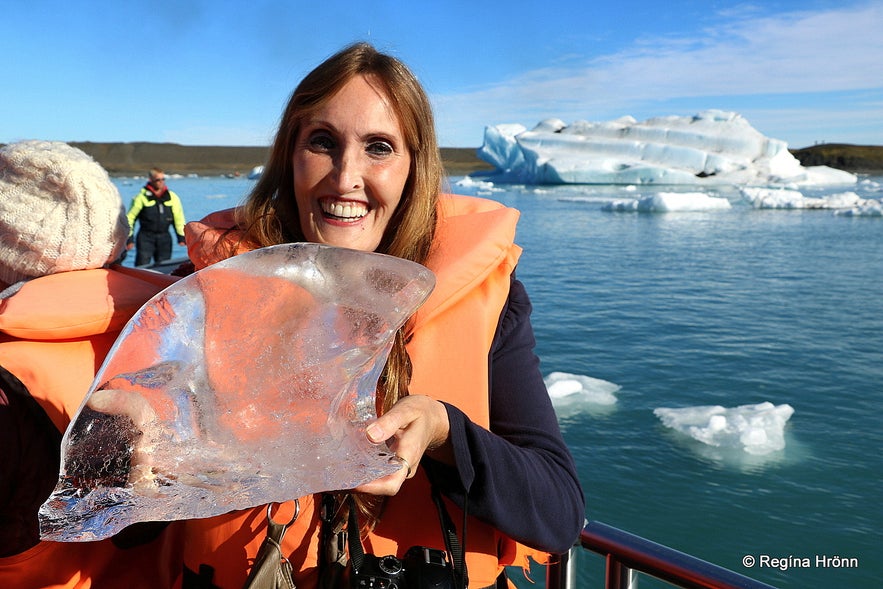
184,43 -> 585,589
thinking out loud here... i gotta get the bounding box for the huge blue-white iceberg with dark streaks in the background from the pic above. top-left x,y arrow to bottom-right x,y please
478,110 -> 857,186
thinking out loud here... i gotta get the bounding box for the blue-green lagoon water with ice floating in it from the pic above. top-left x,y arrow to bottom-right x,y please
117,172 -> 883,588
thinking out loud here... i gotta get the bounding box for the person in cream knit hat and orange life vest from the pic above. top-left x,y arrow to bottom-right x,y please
0,141 -> 183,589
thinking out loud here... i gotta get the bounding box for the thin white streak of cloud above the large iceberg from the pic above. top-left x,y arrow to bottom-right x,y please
434,2 -> 883,145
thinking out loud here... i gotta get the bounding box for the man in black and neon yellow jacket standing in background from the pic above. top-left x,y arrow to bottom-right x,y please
126,168 -> 185,266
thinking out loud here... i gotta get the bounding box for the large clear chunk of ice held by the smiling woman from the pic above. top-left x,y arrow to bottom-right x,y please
39,244 -> 435,541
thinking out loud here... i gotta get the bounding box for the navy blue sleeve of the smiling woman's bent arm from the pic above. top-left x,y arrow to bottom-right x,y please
423,278 -> 585,553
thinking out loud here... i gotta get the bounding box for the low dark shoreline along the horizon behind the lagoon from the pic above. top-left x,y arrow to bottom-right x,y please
3,141 -> 883,176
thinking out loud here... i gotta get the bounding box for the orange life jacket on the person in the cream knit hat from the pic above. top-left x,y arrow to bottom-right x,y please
0,266 -> 183,589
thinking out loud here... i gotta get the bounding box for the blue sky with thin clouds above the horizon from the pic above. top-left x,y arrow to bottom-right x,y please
0,0 -> 883,147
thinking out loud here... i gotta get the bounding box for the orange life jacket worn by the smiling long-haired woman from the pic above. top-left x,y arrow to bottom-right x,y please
185,195 -> 547,589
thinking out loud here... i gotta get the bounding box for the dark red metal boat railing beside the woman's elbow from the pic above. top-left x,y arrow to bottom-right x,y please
546,521 -> 775,589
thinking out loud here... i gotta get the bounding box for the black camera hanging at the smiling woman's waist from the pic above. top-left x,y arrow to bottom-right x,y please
350,546 -> 463,589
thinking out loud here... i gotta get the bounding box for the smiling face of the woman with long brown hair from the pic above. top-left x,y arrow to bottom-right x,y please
292,76 -> 411,251
